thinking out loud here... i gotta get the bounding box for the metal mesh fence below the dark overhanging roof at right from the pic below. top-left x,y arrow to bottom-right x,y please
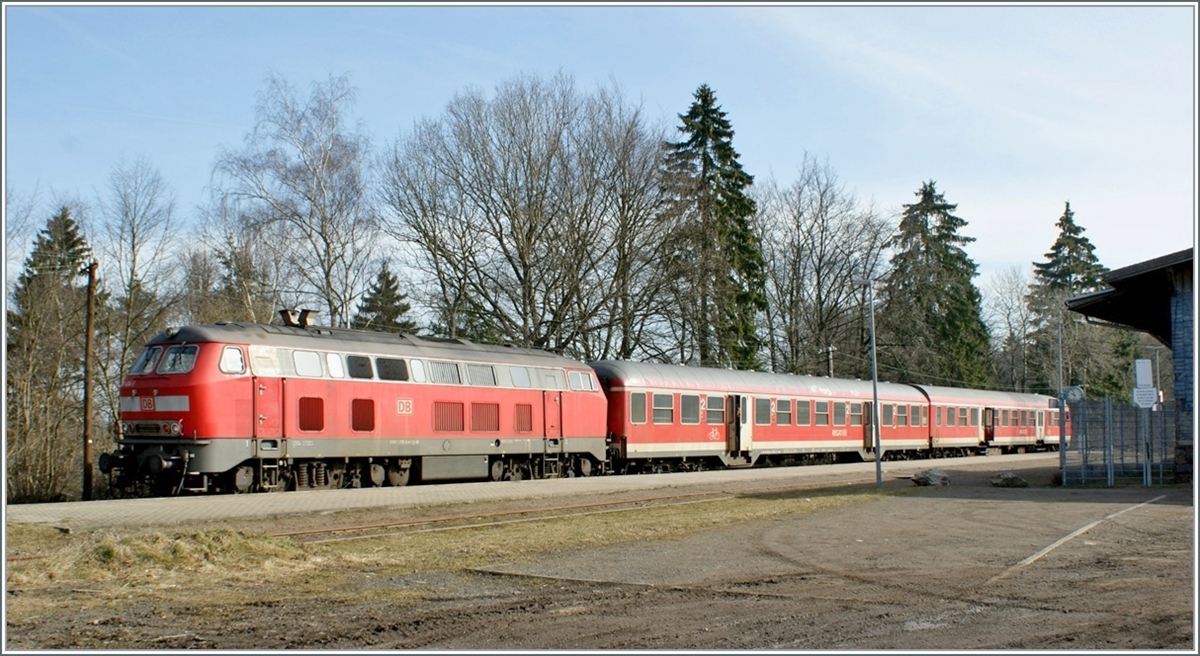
1061,397 -> 1176,486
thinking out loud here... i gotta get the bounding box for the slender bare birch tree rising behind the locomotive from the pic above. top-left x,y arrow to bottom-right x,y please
215,74 -> 379,326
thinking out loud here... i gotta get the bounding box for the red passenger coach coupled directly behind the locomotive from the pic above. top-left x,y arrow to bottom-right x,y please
592,361 -> 929,470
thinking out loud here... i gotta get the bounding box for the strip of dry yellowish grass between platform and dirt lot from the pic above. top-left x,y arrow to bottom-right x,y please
6,489 -> 905,619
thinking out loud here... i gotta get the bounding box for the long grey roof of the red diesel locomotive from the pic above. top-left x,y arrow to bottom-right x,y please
148,321 -> 582,367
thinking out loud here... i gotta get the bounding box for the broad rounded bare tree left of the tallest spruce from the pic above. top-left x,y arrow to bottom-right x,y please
382,74 -> 659,359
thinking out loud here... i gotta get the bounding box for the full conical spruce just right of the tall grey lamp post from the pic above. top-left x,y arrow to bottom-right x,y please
880,181 -> 990,386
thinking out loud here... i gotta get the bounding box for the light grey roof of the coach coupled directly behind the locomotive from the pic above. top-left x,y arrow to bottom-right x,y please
592,361 -> 925,403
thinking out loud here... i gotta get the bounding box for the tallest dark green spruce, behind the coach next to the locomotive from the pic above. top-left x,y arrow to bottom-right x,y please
666,84 -> 767,369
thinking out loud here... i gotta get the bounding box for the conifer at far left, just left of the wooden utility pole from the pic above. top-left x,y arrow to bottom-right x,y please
5,207 -> 94,501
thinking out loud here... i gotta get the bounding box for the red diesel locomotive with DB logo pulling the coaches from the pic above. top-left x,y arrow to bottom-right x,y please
100,323 -> 606,494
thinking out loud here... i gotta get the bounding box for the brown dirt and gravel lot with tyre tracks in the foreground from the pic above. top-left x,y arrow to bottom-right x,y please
6,467 -> 1195,651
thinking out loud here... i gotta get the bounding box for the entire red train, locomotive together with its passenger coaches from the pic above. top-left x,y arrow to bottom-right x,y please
100,313 -> 1069,494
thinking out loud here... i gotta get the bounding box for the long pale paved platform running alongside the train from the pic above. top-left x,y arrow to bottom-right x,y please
5,453 -> 1058,529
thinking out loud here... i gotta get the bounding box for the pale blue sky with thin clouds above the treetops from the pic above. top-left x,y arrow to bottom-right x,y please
4,4 -> 1196,285
